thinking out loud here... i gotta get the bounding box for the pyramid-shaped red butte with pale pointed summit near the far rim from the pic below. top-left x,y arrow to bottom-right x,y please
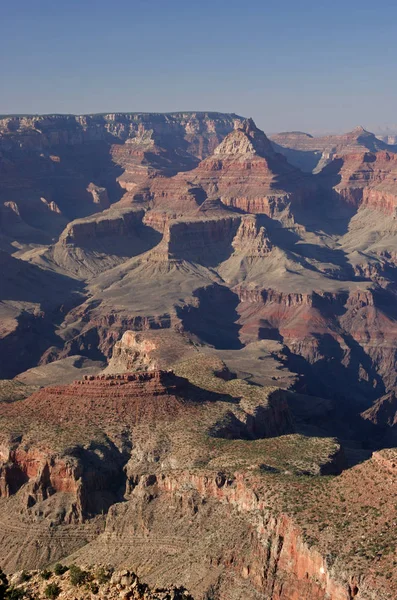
151,119 -> 315,216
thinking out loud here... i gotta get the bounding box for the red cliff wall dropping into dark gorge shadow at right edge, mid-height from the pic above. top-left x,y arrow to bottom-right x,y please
234,286 -> 396,406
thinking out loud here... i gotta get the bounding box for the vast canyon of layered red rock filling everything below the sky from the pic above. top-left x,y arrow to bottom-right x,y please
0,112 -> 397,600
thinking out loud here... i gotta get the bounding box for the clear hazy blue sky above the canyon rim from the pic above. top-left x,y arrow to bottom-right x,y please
0,0 -> 397,133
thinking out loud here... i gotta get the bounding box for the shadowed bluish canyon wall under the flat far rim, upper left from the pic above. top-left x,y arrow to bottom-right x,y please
0,113 -> 239,243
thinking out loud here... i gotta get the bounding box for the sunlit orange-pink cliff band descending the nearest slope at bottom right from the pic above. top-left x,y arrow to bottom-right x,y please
157,472 -> 358,600
